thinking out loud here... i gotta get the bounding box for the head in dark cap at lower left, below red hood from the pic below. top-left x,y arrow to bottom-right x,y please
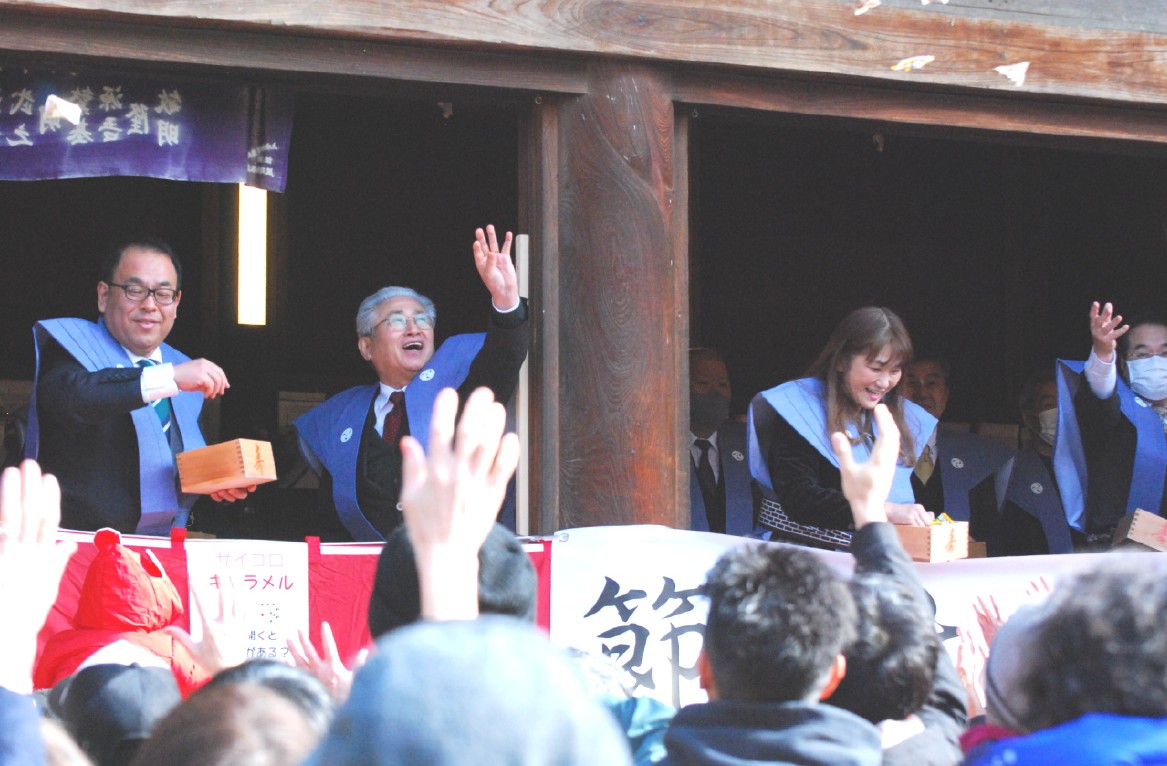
48,664 -> 182,766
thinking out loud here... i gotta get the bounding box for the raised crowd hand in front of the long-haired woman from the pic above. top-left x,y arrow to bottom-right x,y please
831,403 -> 900,529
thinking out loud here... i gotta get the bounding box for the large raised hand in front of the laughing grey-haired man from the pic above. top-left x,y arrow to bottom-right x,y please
401,388 -> 519,620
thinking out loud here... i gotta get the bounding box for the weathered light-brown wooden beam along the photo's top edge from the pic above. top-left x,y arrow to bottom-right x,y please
0,0 -> 1167,103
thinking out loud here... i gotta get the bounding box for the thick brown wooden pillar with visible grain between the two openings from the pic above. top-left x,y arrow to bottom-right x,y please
539,63 -> 689,531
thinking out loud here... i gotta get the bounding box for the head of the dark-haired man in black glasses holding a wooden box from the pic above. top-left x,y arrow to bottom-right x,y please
97,236 -> 182,356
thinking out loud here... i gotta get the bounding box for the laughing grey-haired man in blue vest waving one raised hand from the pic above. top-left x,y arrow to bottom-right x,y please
295,227 -> 530,542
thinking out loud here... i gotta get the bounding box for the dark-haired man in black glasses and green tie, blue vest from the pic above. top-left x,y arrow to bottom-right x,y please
25,237 -> 246,535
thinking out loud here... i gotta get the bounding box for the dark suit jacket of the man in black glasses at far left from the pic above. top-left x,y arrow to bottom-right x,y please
36,341 -> 191,532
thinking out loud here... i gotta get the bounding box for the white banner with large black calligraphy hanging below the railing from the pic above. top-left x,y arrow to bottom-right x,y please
551,525 -> 1124,706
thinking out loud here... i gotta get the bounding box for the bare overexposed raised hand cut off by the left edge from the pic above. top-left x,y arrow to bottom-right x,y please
0,460 -> 77,694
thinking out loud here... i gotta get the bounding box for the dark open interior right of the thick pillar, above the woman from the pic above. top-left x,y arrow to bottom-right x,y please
692,118 -> 1167,423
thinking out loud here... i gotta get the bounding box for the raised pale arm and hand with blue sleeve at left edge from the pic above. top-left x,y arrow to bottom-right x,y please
0,460 -> 76,766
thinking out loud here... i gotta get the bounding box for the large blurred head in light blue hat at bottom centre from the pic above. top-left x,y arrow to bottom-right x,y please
307,615 -> 630,766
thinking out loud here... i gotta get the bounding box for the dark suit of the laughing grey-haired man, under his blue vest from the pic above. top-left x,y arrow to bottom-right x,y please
315,301 -> 531,542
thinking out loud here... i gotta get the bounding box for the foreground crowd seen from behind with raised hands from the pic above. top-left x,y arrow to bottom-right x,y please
0,389 -> 1167,766
